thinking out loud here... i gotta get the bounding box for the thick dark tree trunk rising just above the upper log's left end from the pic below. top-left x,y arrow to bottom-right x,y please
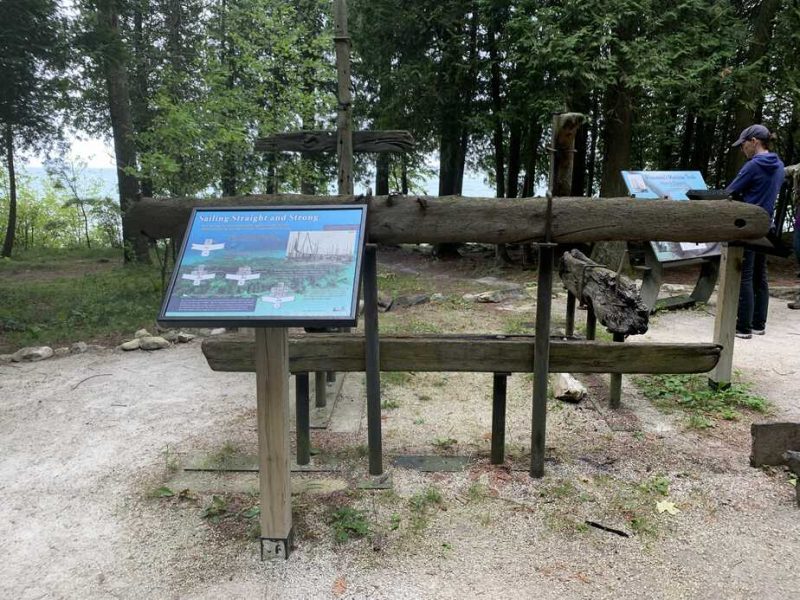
97,0 -> 150,262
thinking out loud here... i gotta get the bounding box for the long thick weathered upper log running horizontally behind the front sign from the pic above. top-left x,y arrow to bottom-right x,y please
126,194 -> 770,244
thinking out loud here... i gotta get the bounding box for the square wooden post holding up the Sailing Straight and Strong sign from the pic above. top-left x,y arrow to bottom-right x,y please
255,327 -> 292,560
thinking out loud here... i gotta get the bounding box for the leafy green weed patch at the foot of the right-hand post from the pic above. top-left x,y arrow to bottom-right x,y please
633,374 -> 769,429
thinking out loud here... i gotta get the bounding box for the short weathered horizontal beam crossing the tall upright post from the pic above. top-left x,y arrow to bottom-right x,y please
255,131 -> 414,153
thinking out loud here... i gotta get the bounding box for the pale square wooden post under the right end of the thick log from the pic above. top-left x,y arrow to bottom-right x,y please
708,244 -> 744,389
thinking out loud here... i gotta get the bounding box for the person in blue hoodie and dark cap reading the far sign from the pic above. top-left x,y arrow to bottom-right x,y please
725,125 -> 784,339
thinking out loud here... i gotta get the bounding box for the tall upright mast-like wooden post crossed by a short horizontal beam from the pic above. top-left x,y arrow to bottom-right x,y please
333,0 -> 353,195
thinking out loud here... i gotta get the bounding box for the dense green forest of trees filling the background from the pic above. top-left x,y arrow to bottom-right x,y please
0,0 -> 800,258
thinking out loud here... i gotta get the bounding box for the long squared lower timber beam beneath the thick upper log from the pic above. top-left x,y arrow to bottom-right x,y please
203,334 -> 721,373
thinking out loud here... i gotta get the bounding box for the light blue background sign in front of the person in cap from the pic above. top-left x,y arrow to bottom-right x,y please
622,171 -> 720,262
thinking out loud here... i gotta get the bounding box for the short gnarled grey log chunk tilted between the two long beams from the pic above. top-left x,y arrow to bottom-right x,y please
558,249 -> 650,335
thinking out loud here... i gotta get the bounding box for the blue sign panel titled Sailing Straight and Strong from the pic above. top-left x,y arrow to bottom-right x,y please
158,205 -> 367,327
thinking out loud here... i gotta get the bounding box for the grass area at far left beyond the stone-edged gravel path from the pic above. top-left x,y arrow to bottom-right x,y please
0,247 -> 161,351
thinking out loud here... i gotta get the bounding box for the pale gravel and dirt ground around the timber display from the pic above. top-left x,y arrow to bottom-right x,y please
0,245 -> 800,599
